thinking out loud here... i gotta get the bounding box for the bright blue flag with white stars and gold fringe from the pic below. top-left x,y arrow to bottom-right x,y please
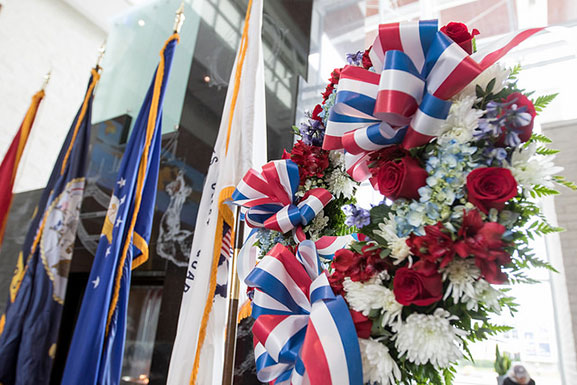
62,34 -> 178,385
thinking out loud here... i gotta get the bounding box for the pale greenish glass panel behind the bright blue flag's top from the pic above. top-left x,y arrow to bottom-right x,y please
92,0 -> 200,133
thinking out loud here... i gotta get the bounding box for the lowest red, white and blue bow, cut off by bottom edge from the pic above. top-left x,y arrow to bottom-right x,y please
245,241 -> 363,385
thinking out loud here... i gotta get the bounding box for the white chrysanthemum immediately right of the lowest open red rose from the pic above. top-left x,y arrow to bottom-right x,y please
442,258 -> 481,303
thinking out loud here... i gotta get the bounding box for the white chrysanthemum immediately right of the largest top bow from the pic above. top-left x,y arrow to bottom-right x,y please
438,96 -> 483,145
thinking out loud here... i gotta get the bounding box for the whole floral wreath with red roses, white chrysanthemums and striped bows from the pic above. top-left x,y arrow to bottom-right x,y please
233,21 -> 576,385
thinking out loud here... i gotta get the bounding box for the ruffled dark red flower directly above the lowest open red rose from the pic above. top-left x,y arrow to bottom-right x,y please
407,222 -> 455,267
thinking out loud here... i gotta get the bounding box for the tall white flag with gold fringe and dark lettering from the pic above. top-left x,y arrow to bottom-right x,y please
167,0 -> 266,385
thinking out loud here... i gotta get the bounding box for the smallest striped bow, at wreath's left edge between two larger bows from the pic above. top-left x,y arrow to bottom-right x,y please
232,159 -> 333,234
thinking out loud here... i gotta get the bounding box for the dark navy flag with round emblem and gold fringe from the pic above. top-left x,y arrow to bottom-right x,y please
0,68 -> 100,385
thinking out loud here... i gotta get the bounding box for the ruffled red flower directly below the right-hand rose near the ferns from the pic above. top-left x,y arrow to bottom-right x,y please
455,210 -> 511,284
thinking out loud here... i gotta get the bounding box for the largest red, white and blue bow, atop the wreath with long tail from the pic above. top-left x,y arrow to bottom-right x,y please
323,20 -> 542,181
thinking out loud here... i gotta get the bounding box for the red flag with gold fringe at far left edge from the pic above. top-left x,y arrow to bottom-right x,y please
0,90 -> 44,245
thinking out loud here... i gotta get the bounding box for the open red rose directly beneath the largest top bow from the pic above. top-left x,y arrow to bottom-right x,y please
371,156 -> 429,200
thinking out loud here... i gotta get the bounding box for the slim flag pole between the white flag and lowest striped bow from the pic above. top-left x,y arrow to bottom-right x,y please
222,206 -> 244,385
